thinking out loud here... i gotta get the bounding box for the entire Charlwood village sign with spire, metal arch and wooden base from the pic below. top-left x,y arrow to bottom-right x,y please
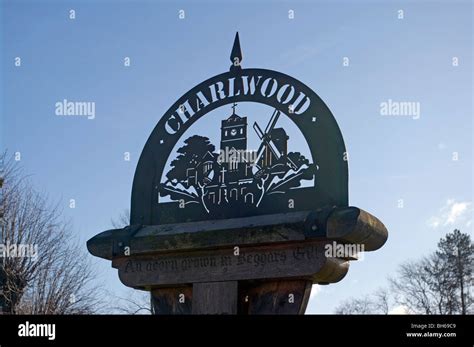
87,33 -> 388,314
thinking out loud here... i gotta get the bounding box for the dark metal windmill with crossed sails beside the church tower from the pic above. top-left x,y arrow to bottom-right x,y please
253,109 -> 296,169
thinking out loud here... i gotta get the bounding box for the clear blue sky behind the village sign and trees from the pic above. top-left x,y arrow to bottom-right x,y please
0,1 -> 473,313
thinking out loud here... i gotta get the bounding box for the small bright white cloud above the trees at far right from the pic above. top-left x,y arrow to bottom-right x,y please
428,199 -> 472,229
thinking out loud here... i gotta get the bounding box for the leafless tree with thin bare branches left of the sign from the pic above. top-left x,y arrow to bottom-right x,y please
0,153 -> 100,314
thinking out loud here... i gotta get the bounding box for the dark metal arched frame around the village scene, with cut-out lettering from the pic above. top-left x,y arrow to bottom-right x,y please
131,69 -> 348,225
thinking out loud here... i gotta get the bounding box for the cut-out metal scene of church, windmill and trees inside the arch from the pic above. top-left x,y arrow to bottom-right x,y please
162,103 -> 311,213
